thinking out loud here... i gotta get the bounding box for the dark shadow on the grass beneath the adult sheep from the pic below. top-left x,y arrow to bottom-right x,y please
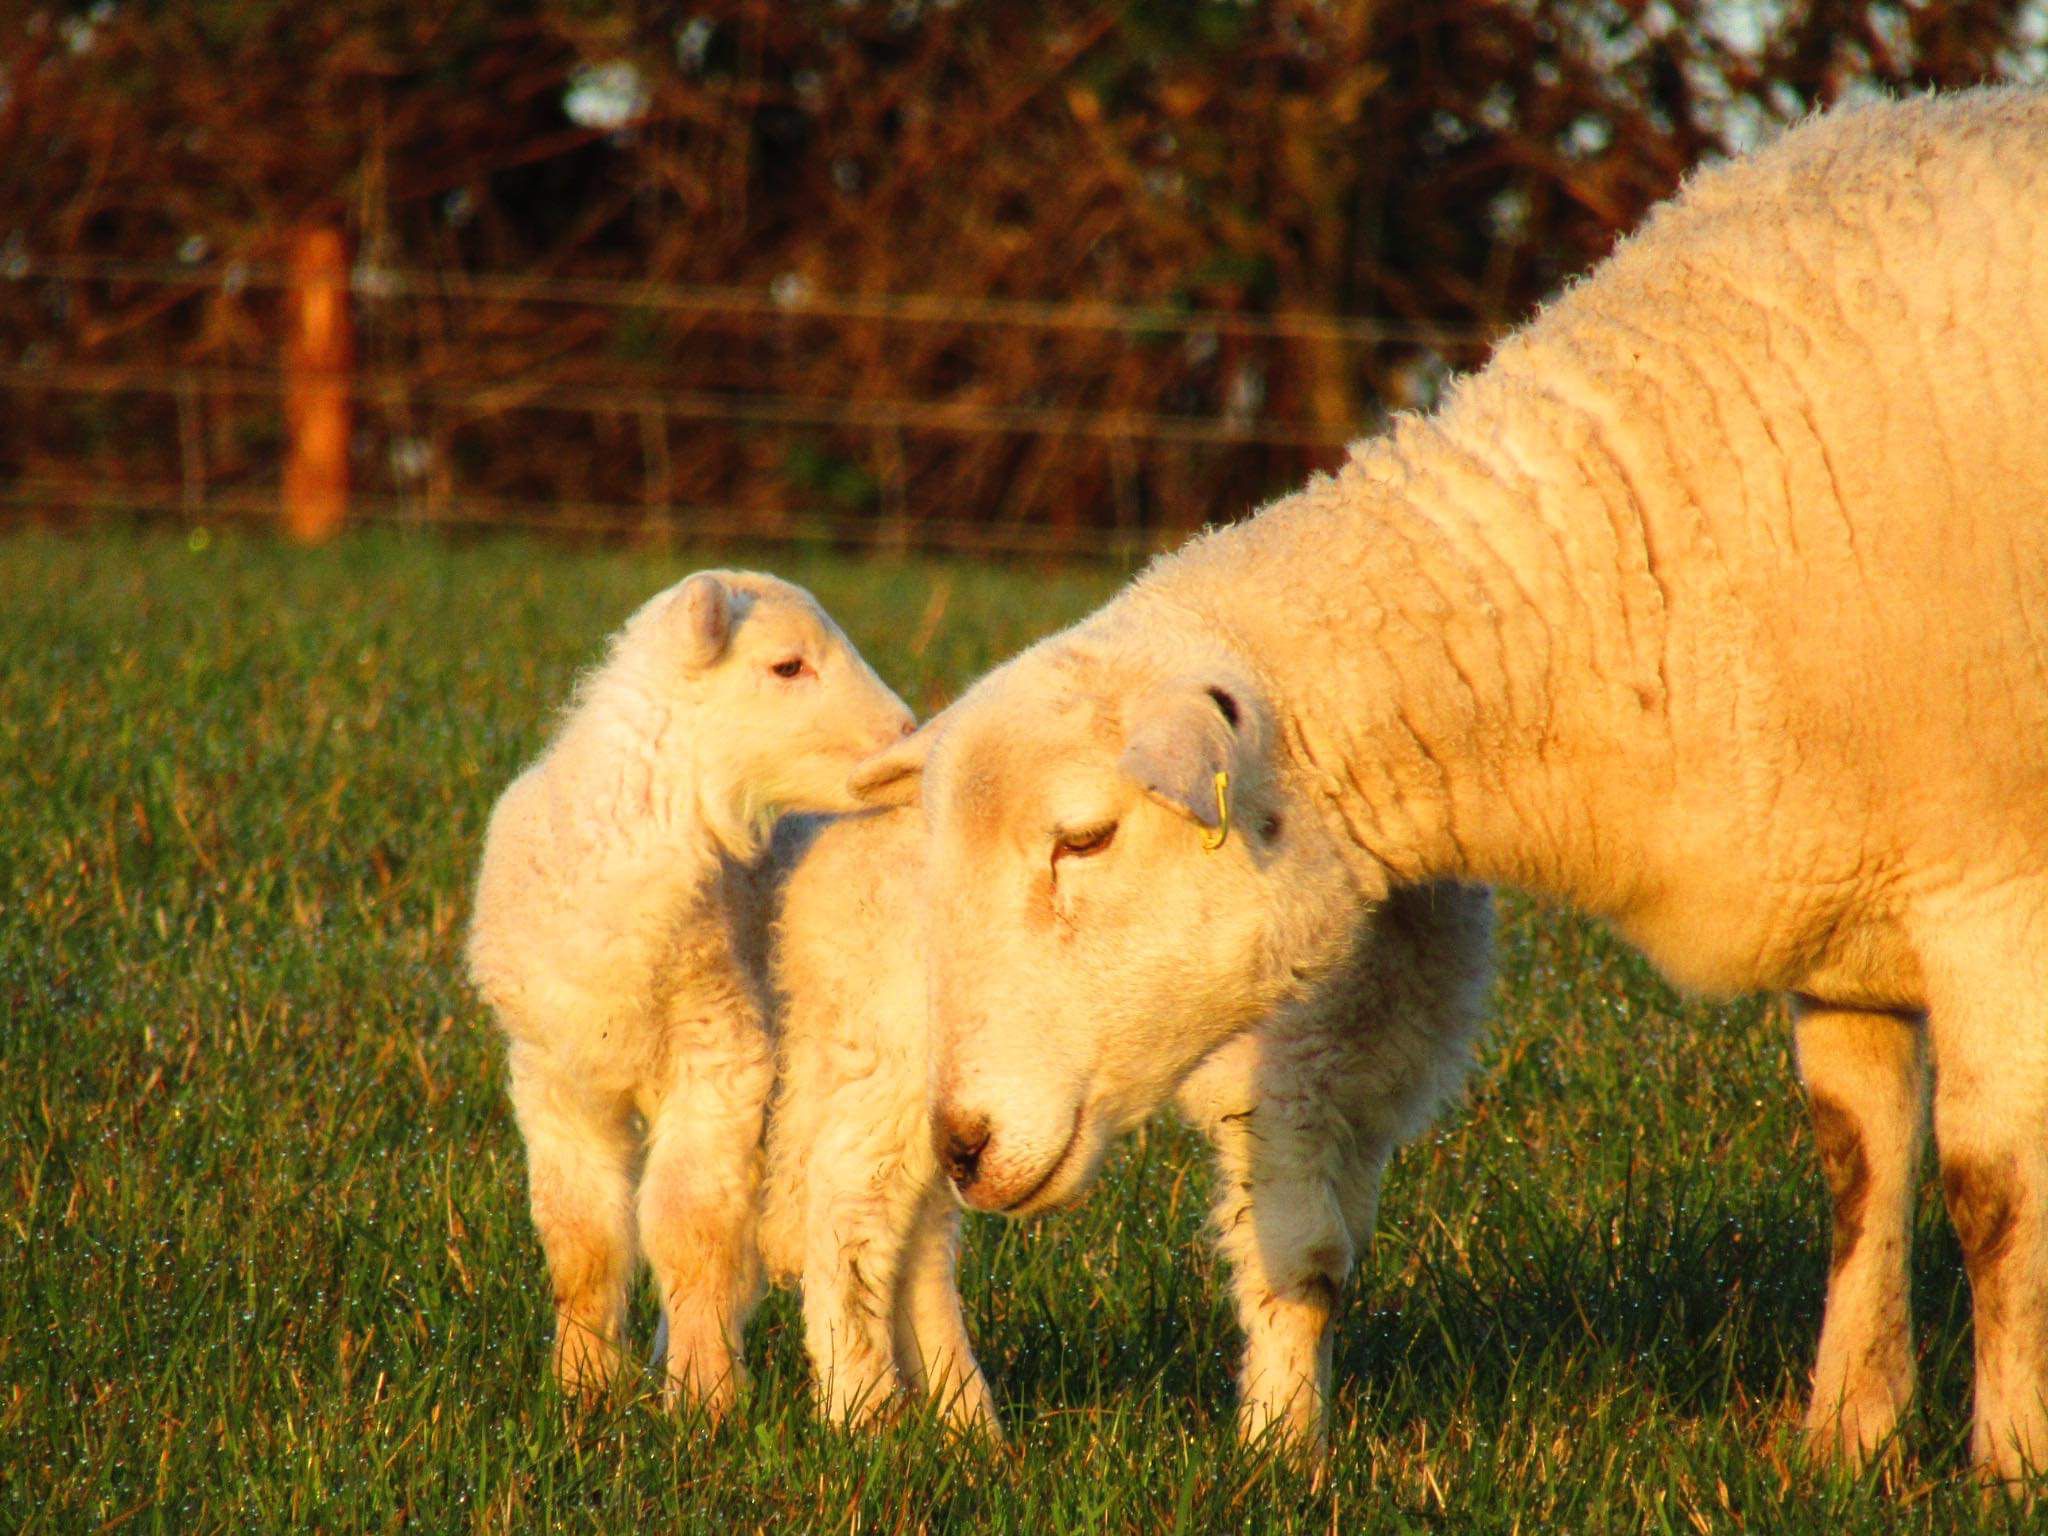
973,1161 -> 1970,1448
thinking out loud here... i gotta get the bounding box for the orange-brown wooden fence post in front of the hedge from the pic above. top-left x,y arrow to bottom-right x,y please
285,225 -> 354,545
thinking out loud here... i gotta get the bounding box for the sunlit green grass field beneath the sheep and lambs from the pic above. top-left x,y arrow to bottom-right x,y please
0,535 -> 2038,1532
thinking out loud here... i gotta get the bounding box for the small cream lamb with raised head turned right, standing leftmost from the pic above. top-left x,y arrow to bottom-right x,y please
469,571 -> 911,1413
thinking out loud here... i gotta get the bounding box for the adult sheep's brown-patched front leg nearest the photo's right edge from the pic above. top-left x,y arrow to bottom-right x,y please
1923,925 -> 2048,1483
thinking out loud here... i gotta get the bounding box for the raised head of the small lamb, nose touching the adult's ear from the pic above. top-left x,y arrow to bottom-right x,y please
627,571 -> 915,854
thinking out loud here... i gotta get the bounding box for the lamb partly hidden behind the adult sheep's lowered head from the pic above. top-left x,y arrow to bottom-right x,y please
762,811 -> 1493,1456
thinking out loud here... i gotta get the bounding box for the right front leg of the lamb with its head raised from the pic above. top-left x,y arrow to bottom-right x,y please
639,1028 -> 774,1417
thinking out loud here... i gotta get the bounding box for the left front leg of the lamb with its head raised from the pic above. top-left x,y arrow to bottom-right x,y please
512,1051 -> 635,1397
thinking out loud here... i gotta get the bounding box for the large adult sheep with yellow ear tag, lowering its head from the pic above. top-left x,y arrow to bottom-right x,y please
856,90 -> 2048,1477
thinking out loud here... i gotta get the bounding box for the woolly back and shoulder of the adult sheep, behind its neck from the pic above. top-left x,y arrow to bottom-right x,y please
1433,90 -> 2048,868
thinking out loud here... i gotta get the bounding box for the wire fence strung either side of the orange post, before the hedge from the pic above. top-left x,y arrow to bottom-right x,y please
0,248 -> 1491,557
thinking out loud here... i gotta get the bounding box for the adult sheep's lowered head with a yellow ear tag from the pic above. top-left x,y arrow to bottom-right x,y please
854,610 -> 1356,1214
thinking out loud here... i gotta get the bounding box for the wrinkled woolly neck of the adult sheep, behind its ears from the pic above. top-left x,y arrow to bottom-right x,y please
1169,403 -> 1669,913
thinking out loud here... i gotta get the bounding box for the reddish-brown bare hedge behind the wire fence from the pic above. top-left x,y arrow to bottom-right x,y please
0,0 -> 2042,537
